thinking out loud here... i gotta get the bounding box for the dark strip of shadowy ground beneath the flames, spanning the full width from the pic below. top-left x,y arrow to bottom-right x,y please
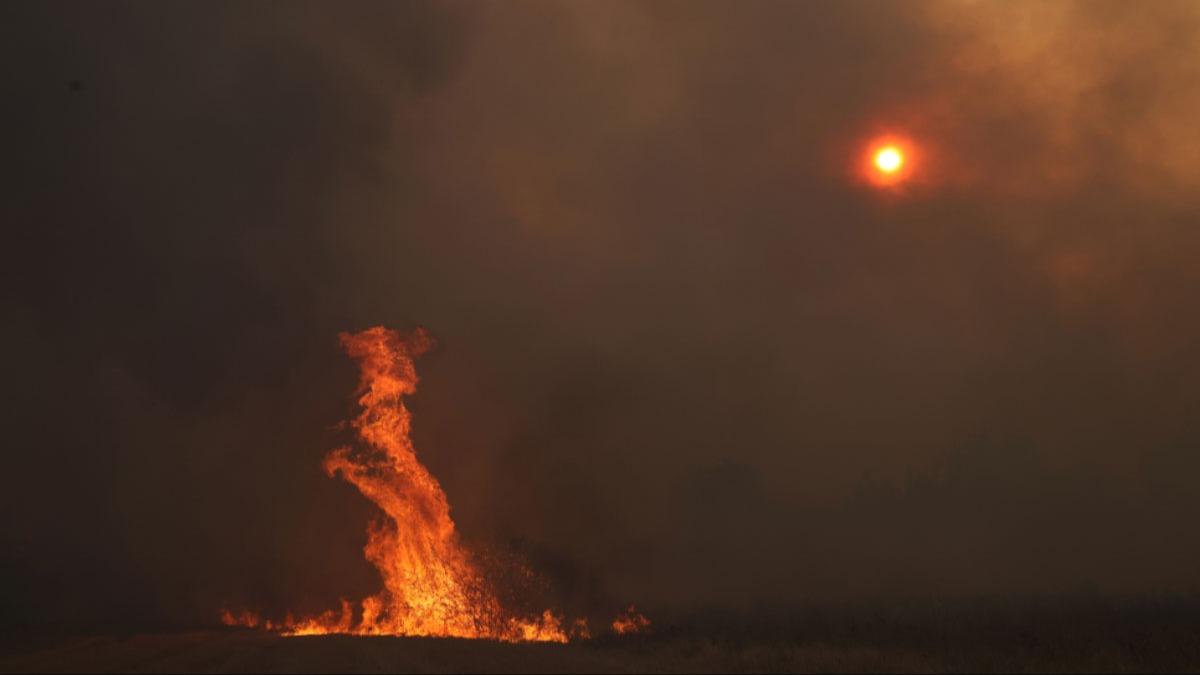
7,602 -> 1200,673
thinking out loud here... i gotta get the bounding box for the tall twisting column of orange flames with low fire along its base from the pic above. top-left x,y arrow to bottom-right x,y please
221,327 -> 649,643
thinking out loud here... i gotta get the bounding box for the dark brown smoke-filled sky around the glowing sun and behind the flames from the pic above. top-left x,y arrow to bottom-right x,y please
7,1 -> 1200,625
